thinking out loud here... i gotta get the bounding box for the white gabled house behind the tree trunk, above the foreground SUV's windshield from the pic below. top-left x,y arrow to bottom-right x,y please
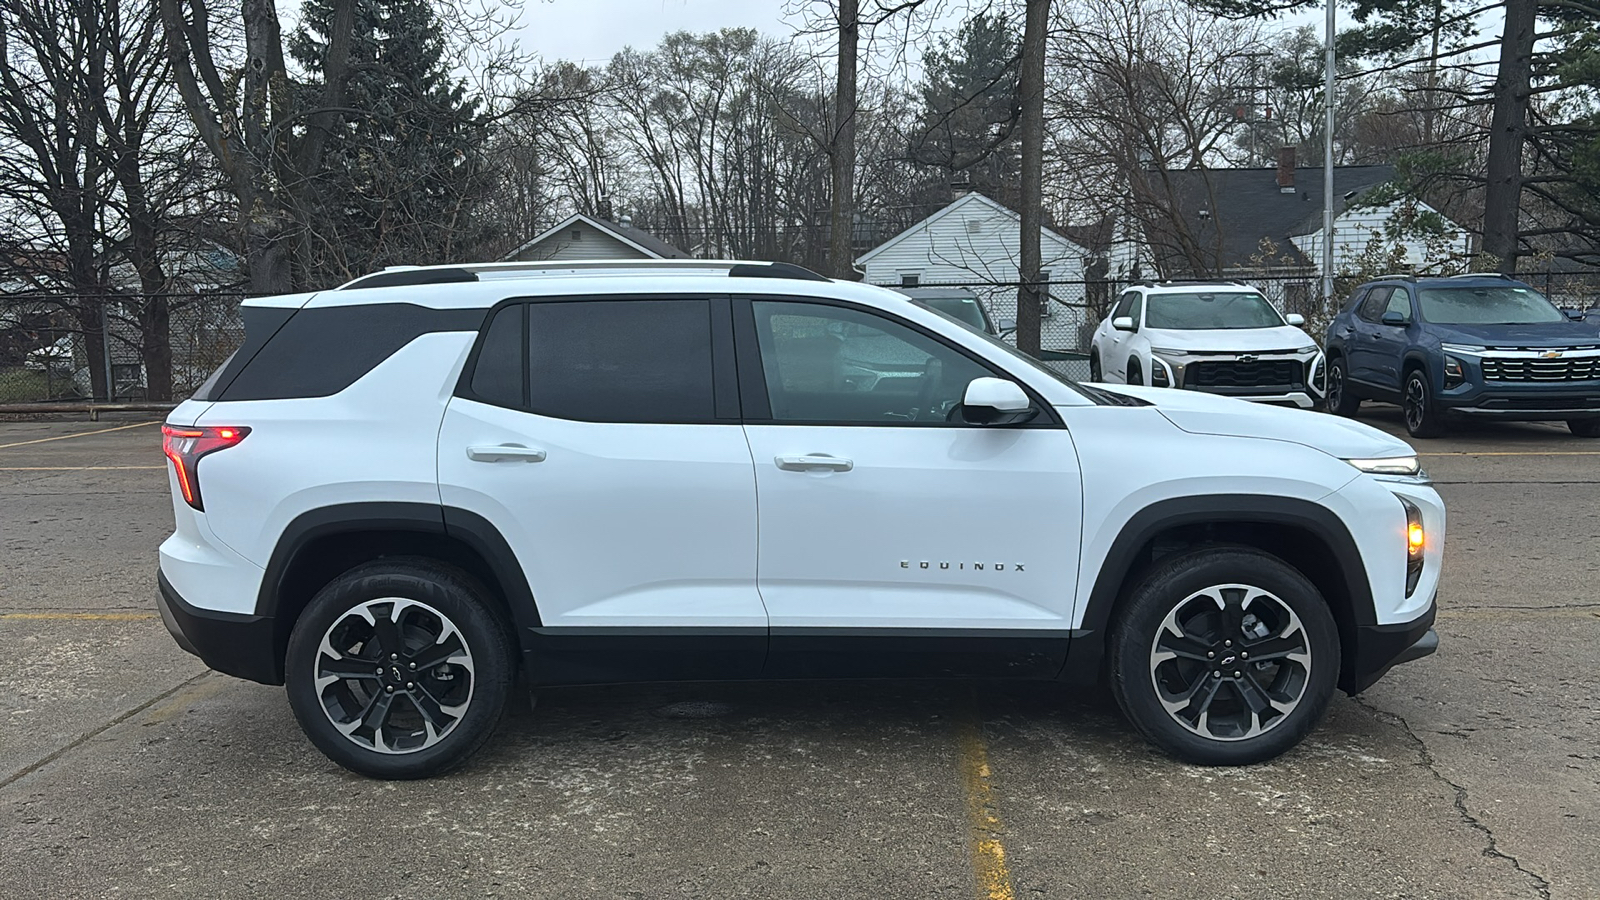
856,192 -> 1090,351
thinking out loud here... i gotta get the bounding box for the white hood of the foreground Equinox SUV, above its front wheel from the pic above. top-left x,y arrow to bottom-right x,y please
1096,384 -> 1416,460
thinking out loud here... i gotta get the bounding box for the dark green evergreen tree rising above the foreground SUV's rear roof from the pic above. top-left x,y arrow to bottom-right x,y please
288,0 -> 488,283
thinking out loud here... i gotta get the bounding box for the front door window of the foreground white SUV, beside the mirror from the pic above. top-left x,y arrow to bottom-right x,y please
750,301 -> 994,424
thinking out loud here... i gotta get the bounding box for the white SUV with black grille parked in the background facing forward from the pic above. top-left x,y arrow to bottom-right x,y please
1090,282 -> 1323,408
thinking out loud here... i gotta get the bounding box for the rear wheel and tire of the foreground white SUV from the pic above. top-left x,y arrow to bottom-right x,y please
283,557 -> 515,778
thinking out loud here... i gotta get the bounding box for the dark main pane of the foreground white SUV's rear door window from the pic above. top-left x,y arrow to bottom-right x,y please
528,299 -> 714,423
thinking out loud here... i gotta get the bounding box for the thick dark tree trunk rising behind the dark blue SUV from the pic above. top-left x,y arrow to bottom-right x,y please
1483,0 -> 1536,274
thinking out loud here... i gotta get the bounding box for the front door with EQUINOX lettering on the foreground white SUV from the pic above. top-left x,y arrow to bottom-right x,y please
734,299 -> 1082,677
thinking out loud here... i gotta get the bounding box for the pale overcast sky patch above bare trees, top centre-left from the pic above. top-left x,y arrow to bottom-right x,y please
520,0 -> 794,64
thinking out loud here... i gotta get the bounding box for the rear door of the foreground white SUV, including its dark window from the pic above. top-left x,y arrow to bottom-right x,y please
438,296 -> 766,682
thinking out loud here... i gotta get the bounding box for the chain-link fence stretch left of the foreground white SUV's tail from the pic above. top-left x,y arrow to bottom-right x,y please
0,293 -> 245,404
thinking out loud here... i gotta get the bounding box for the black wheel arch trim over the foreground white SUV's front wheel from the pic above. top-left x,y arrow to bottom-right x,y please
1061,493 -> 1378,682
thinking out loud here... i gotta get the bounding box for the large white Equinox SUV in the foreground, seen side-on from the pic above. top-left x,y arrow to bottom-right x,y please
160,261 -> 1445,778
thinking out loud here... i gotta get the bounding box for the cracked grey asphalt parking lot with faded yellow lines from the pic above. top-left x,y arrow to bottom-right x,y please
0,408 -> 1600,898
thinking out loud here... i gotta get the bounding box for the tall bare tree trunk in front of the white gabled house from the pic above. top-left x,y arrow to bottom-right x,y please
1016,0 -> 1050,357
